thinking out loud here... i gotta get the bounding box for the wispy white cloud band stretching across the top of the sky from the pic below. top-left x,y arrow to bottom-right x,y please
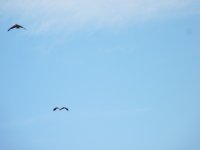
0,0 -> 199,32
